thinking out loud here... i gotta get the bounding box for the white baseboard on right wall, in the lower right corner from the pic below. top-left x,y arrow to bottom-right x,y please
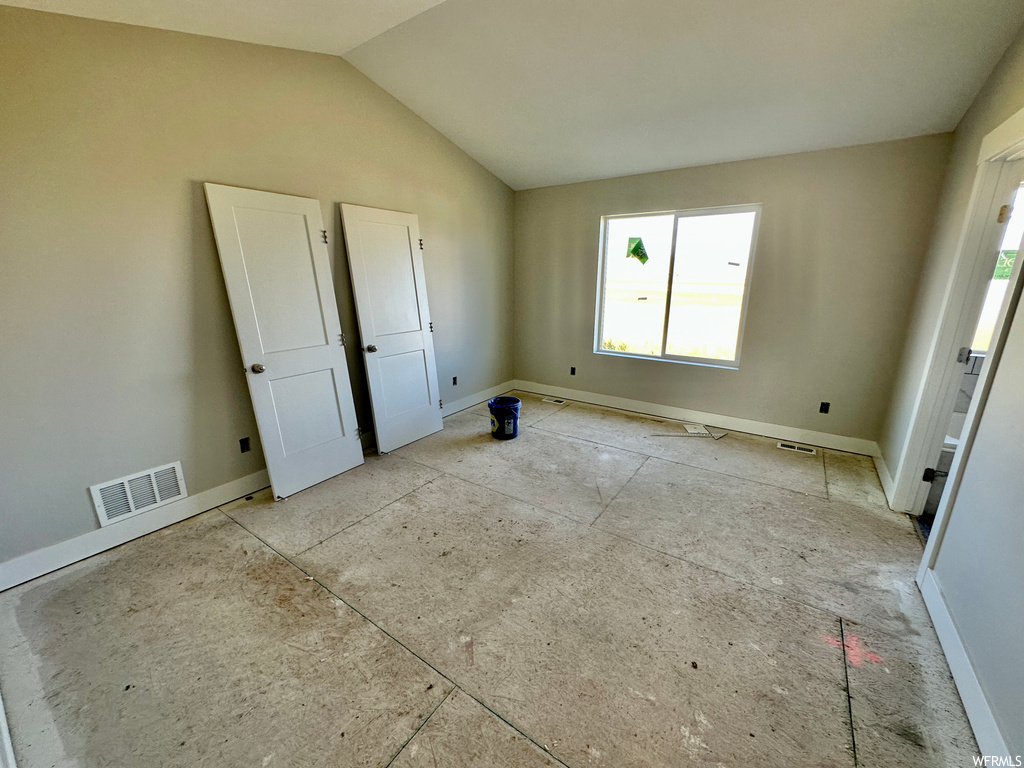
919,570 -> 1010,765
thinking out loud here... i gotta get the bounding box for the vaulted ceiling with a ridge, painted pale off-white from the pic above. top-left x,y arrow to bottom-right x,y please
3,0 -> 1024,189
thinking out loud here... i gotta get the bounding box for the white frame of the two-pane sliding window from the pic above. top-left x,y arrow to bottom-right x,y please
594,203 -> 762,370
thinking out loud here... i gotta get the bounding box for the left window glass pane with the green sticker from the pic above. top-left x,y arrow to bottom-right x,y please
601,214 -> 675,355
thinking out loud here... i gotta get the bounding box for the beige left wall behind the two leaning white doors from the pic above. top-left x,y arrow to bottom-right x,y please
0,6 -> 512,561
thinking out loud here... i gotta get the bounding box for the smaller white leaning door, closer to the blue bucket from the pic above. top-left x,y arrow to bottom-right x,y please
341,203 -> 442,454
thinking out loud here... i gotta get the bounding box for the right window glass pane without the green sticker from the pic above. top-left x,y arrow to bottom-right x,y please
666,211 -> 757,360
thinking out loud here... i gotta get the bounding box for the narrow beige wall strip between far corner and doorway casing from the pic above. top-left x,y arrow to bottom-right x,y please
880,22 -> 1024,487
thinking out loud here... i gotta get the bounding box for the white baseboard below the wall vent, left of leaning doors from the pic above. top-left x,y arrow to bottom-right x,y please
0,469 -> 270,593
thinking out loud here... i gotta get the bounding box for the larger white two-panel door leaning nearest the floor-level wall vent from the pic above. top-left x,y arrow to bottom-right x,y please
204,184 -> 362,498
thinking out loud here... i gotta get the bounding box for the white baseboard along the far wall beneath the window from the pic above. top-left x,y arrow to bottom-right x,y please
514,380 -> 881,457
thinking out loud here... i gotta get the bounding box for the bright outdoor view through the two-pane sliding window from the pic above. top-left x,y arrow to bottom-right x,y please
595,205 -> 761,367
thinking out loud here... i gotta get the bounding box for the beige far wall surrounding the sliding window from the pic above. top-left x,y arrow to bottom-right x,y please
515,134 -> 951,440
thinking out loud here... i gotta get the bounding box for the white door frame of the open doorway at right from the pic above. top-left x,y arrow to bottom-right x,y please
876,103 -> 1024,512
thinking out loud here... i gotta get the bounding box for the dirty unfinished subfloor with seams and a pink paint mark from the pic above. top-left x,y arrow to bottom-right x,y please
0,393 -> 978,768
